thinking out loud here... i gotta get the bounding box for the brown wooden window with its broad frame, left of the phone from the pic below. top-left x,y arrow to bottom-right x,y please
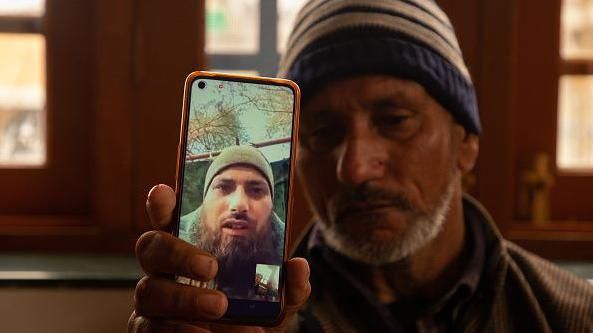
0,0 -> 204,249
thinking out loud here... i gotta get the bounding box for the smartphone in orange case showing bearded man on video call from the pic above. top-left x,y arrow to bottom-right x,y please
175,72 -> 300,326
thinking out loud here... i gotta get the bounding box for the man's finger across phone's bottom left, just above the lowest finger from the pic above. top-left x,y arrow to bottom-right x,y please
134,277 -> 228,322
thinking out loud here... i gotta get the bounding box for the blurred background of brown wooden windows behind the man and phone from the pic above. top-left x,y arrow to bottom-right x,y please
0,0 -> 593,333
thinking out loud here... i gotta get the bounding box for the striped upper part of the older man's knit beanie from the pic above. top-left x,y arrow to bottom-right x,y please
279,0 -> 471,82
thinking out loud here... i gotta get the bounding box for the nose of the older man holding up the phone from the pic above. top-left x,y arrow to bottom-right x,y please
337,120 -> 388,186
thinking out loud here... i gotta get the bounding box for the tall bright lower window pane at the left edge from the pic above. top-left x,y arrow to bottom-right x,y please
0,33 -> 45,165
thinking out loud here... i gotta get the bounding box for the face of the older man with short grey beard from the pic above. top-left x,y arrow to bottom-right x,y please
298,75 -> 477,264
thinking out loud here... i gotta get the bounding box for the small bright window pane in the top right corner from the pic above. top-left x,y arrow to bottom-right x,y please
561,0 -> 593,59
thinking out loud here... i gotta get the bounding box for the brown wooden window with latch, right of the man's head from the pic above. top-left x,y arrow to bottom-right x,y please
477,0 -> 593,260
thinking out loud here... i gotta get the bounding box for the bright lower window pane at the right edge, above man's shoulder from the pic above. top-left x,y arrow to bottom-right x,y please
557,75 -> 593,170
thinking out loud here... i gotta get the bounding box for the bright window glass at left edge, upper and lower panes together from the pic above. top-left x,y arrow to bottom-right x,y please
0,0 -> 46,167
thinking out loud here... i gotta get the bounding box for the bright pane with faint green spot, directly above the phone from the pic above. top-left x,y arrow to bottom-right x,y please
206,0 -> 258,54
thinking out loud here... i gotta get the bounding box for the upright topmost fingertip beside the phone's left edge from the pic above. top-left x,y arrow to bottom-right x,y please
146,184 -> 175,230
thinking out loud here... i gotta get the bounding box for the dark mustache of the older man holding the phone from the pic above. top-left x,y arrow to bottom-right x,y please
330,184 -> 418,219
